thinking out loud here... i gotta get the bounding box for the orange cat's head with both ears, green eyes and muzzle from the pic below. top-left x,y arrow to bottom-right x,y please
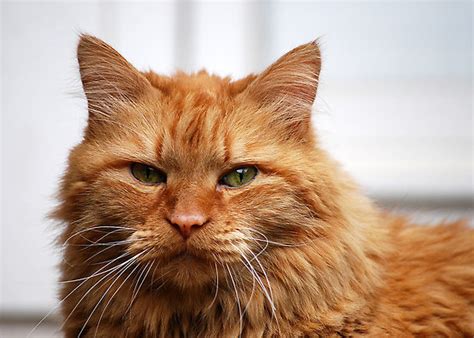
58,36 -> 324,287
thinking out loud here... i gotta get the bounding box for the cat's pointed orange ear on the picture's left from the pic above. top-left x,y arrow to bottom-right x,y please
77,35 -> 150,117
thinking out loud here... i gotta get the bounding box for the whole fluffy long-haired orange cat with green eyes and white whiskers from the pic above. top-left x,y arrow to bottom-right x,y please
53,35 -> 474,337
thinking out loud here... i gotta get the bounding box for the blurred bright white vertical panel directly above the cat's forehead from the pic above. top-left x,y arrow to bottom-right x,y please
187,1 -> 263,79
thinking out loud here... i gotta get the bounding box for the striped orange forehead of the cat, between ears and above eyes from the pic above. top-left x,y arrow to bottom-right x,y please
125,72 -> 262,172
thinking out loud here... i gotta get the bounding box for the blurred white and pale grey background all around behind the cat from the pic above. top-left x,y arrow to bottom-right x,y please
0,1 -> 474,337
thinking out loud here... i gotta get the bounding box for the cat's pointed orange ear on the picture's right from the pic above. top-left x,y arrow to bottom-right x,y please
246,41 -> 321,137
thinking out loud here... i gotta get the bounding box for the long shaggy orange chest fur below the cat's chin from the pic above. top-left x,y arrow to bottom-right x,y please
63,274 -> 368,338
